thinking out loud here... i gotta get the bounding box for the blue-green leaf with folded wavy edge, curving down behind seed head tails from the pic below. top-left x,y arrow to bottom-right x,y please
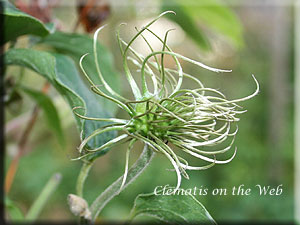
5,49 -> 116,159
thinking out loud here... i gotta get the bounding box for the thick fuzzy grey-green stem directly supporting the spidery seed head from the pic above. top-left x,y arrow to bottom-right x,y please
90,145 -> 155,222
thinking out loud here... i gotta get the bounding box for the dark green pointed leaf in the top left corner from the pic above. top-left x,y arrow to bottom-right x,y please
0,0 -> 53,45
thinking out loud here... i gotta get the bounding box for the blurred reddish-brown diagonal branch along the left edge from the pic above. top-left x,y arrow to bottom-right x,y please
4,82 -> 50,194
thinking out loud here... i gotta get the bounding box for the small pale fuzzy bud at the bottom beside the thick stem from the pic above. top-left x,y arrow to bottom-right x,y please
68,194 -> 91,220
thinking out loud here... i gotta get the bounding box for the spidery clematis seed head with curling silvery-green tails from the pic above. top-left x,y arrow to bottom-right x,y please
74,11 -> 259,190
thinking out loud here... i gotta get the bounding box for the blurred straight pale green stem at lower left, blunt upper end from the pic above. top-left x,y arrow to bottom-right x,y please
25,173 -> 61,221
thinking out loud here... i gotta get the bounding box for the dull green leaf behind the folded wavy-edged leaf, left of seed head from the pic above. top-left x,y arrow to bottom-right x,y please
41,32 -> 121,113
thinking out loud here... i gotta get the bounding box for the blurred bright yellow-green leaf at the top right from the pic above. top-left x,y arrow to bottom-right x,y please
162,0 -> 244,49
